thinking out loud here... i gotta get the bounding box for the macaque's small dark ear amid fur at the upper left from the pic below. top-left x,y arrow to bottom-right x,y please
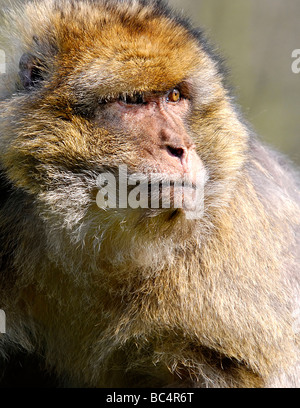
19,53 -> 43,89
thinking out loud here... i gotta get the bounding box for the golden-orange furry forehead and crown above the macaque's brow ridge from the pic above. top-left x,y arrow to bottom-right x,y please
15,0 -> 216,94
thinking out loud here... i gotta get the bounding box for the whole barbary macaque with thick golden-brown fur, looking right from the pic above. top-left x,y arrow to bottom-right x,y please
0,0 -> 300,388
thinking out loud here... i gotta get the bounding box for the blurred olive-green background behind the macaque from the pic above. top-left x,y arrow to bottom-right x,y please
0,0 -> 300,164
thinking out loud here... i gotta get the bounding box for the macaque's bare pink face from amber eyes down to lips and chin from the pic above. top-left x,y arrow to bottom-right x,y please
94,86 -> 206,215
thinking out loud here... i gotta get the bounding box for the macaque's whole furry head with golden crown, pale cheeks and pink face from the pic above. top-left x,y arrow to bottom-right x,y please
0,2 -> 246,249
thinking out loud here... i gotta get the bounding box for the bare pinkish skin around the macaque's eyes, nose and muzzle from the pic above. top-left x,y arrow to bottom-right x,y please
94,88 -> 206,214
